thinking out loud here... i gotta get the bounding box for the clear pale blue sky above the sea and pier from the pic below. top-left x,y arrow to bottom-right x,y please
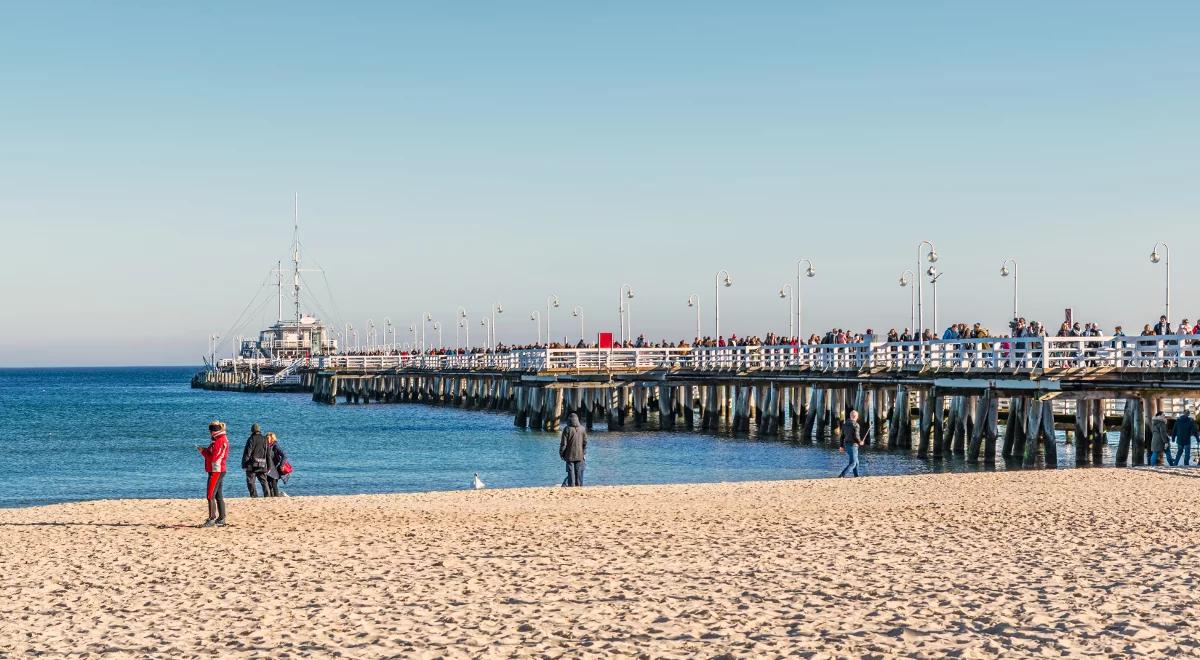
0,1 -> 1200,367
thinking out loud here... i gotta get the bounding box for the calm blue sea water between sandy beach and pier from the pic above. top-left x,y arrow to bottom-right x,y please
0,367 -> 1094,506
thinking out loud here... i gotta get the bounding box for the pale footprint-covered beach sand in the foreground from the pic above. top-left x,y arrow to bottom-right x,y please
0,469 -> 1200,658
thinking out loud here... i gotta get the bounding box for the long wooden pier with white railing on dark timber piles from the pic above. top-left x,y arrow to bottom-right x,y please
194,336 -> 1200,467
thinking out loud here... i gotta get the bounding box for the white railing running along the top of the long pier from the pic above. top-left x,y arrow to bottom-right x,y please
314,335 -> 1200,372
